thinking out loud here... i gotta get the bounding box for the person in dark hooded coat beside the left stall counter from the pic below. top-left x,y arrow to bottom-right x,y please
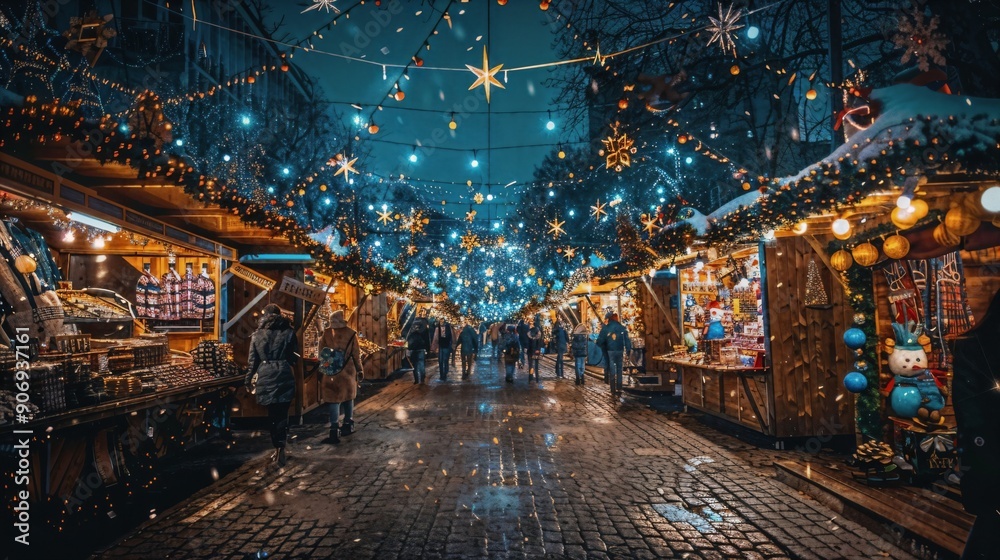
243,303 -> 299,467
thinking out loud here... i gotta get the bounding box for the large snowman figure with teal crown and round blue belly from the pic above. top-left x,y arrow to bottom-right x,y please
885,321 -> 948,424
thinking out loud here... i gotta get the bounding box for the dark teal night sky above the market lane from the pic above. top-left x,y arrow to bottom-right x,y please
271,0 -> 584,218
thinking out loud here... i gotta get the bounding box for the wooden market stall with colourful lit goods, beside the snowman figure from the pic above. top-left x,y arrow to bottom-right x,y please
653,235 -> 854,439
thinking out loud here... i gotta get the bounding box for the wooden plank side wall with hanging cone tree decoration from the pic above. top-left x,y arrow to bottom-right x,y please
764,236 -> 854,437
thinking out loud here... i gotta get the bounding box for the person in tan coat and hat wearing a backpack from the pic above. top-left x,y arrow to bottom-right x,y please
319,309 -> 365,444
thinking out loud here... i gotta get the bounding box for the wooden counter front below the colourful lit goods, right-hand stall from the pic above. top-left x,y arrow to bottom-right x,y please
653,356 -> 776,436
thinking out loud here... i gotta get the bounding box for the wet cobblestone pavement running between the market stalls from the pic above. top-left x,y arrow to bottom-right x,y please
98,354 -> 910,560
